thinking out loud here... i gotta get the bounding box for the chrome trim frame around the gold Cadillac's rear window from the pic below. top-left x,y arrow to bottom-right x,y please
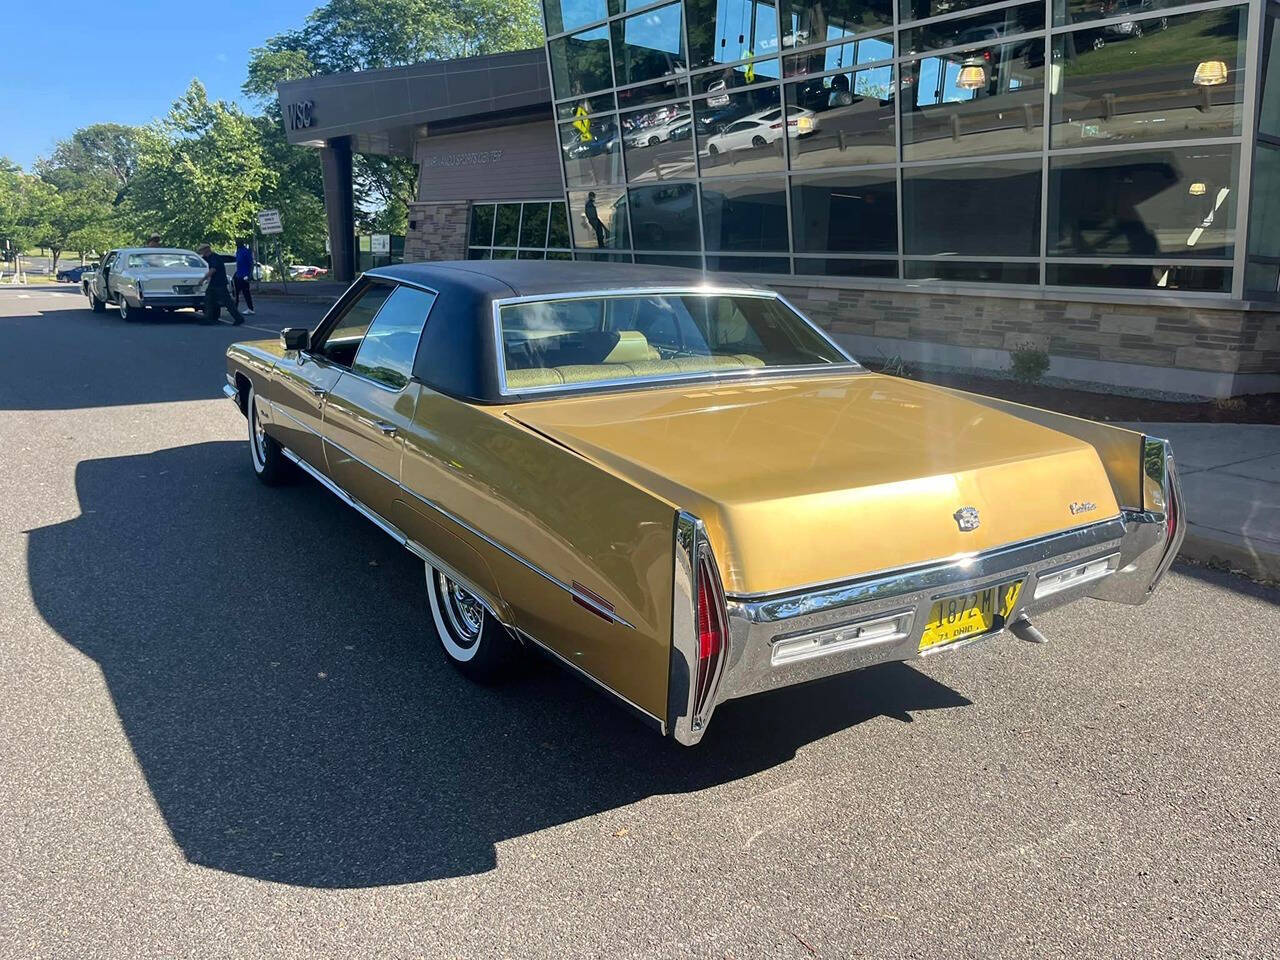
492,285 -> 865,397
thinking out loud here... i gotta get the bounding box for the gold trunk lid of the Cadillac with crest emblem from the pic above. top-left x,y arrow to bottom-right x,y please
507,374 -> 1119,595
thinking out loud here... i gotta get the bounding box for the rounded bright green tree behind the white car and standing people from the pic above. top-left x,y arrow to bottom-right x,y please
125,81 -> 278,247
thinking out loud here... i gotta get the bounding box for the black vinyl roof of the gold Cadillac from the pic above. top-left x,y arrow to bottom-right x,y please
355,260 -> 768,403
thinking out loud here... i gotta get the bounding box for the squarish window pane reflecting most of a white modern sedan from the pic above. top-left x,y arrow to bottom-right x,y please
694,86 -> 786,175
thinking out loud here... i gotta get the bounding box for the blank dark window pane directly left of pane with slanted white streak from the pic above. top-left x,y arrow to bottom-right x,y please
902,156 -> 1041,257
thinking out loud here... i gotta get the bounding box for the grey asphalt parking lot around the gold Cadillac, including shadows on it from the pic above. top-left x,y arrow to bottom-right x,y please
0,288 -> 1280,959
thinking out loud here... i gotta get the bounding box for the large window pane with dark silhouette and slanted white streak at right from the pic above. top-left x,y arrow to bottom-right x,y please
1048,146 -> 1239,259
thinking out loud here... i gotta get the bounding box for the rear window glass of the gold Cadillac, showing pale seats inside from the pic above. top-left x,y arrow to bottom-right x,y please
499,293 -> 852,390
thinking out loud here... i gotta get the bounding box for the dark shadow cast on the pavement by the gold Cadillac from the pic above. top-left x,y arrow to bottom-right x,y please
28,442 -> 969,887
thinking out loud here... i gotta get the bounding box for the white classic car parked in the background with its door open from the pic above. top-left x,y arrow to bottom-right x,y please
81,247 -> 232,320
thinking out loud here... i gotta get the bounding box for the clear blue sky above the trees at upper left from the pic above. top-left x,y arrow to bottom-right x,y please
0,0 -> 323,169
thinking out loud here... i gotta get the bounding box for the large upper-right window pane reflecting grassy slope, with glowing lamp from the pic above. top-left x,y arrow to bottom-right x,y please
1052,6 -> 1245,147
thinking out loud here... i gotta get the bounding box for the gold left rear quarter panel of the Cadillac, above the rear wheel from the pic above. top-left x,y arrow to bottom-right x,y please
398,389 -> 676,718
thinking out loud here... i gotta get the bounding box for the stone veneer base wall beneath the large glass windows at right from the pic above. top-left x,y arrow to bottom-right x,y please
777,284 -> 1280,392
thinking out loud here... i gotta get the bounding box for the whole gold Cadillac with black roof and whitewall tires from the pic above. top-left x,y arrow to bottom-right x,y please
225,261 -> 1185,745
